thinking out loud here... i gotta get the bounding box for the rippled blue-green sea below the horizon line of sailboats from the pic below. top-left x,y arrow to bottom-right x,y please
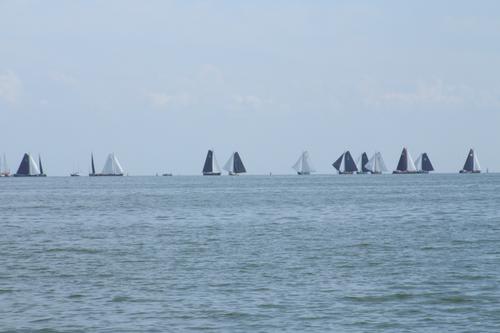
0,174 -> 500,332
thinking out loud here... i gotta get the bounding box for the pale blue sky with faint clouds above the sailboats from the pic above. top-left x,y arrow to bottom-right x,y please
0,0 -> 500,175
